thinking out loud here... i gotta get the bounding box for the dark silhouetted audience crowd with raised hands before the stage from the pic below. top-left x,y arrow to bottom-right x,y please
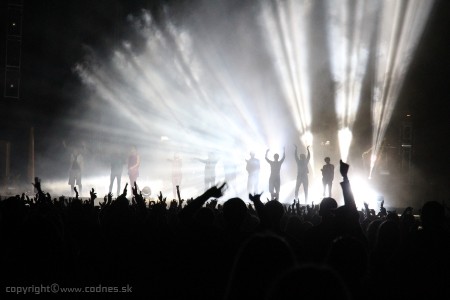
0,158 -> 450,300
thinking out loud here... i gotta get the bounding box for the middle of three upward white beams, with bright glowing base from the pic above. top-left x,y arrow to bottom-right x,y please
326,0 -> 376,160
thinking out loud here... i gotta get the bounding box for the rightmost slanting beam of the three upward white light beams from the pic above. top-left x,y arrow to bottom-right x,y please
371,0 -> 434,176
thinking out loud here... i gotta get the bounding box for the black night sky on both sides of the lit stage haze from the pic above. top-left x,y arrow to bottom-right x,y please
0,0 -> 450,191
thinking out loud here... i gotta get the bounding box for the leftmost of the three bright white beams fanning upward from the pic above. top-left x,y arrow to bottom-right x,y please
260,0 -> 312,145
